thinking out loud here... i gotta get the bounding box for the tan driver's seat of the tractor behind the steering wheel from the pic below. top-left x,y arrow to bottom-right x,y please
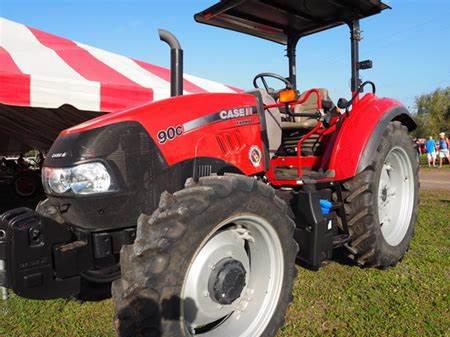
281,88 -> 331,130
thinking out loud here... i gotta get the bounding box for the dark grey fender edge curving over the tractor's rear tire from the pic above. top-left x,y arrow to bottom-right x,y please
356,106 -> 417,174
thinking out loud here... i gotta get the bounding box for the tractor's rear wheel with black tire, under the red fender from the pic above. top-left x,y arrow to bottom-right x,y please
343,122 -> 419,268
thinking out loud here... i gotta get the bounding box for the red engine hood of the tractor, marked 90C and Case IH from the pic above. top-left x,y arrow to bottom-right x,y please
62,93 -> 264,175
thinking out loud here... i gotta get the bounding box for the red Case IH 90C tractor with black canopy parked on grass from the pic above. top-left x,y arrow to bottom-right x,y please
0,0 -> 419,337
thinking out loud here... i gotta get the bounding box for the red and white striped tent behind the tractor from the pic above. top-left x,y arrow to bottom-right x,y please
0,17 -> 240,154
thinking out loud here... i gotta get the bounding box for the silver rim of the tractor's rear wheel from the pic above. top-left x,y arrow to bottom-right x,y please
378,147 -> 415,246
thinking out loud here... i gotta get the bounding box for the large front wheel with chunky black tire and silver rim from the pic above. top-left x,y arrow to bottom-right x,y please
112,175 -> 298,337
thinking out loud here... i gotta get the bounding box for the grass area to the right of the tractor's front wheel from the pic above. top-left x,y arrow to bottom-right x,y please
279,192 -> 450,337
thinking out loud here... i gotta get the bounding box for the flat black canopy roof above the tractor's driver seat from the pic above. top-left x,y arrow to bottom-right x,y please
195,0 -> 390,44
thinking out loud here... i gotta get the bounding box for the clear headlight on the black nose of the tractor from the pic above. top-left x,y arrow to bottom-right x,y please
42,163 -> 111,194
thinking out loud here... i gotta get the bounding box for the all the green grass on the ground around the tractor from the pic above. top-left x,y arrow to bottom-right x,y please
0,192 -> 450,337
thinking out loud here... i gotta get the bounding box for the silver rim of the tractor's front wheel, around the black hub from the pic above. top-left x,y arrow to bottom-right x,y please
181,214 -> 284,337
